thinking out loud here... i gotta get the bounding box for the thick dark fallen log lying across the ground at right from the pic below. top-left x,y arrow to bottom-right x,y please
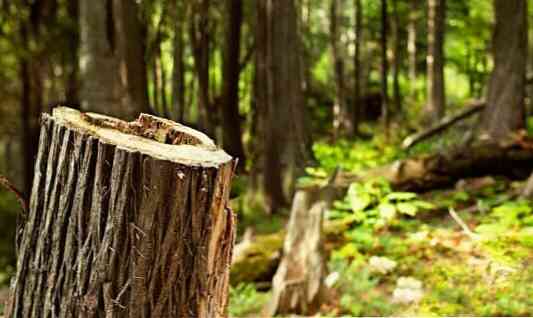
344,135 -> 533,192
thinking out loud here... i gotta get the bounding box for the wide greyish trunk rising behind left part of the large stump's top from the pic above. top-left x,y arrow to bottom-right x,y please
80,0 -> 122,117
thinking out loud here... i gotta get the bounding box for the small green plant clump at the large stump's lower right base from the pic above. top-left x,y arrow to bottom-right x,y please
228,284 -> 269,317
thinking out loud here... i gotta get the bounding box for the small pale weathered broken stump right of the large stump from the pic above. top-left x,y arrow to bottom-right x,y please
265,187 -> 333,316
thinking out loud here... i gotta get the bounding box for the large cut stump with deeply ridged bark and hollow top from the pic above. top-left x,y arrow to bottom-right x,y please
7,108 -> 235,318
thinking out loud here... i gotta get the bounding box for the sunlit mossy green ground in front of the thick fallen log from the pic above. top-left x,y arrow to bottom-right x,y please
230,177 -> 533,317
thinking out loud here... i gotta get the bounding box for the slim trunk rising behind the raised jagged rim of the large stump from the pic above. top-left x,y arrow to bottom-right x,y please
172,1 -> 186,122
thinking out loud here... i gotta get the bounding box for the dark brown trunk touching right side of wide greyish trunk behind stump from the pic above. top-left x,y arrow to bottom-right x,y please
112,0 -> 150,119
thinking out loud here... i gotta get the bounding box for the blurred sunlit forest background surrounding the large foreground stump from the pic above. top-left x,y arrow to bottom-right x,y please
0,0 -> 533,316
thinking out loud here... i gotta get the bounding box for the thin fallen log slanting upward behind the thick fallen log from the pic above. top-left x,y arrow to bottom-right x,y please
402,101 -> 486,150
